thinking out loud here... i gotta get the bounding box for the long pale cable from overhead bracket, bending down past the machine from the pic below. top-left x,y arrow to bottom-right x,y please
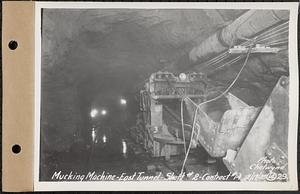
180,40 -> 256,174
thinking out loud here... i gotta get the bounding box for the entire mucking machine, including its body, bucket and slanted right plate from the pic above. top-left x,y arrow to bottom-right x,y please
140,72 -> 289,178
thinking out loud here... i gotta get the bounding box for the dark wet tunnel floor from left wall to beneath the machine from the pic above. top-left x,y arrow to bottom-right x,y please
40,125 -> 228,181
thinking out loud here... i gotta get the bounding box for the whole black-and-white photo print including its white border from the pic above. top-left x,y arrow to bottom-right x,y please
35,3 -> 298,190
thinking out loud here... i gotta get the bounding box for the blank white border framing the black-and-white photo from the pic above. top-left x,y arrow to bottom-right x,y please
34,2 -> 299,191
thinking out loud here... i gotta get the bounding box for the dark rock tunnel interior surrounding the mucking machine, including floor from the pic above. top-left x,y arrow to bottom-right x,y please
40,9 -> 289,180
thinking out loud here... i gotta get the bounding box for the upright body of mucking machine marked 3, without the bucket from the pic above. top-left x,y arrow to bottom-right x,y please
140,72 -> 207,159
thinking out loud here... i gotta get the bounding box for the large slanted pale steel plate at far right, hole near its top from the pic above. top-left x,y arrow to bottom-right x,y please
223,76 -> 289,181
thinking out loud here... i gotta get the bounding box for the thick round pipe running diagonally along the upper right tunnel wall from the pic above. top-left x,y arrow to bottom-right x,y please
189,10 -> 289,63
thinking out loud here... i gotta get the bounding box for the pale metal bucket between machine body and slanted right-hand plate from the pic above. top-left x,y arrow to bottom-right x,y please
185,93 -> 260,157
